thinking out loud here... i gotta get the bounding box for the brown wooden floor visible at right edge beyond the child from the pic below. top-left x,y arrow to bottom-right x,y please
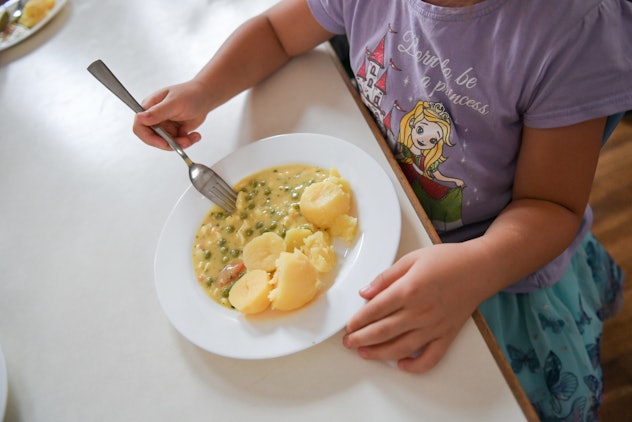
590,114 -> 632,422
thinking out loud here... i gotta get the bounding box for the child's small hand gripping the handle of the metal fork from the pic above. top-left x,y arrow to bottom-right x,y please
134,80 -> 209,150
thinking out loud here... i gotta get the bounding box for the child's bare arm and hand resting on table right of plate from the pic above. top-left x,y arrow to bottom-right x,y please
343,115 -> 605,372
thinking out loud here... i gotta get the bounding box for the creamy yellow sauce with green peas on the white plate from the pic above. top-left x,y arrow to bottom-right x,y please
193,164 -> 329,307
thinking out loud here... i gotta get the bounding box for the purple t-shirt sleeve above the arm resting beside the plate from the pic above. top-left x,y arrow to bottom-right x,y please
524,0 -> 632,128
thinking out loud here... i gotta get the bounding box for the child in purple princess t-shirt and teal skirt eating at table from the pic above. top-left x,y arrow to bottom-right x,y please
134,0 -> 632,420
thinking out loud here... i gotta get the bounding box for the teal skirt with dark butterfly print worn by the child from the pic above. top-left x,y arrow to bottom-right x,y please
480,234 -> 623,421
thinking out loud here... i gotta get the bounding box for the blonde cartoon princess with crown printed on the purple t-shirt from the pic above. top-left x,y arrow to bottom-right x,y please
397,101 -> 465,231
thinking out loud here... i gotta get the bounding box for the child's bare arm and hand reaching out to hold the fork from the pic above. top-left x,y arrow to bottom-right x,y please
134,0 -> 333,149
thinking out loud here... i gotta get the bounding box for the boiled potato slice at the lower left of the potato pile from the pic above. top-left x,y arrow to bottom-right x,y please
228,270 -> 272,314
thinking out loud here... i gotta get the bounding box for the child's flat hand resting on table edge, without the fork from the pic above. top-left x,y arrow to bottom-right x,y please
343,244 -> 484,372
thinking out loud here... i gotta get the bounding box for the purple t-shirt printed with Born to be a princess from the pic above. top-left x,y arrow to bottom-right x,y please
308,0 -> 632,292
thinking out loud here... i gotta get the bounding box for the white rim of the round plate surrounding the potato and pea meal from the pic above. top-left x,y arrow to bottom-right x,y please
154,134 -> 401,359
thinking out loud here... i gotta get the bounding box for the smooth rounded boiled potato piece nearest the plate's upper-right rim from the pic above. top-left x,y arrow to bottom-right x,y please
299,179 -> 351,228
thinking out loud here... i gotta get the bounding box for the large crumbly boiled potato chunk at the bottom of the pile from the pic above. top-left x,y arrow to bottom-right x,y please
268,251 -> 320,311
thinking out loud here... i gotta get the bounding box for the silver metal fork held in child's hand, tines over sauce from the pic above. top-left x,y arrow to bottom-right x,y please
88,60 -> 237,213
